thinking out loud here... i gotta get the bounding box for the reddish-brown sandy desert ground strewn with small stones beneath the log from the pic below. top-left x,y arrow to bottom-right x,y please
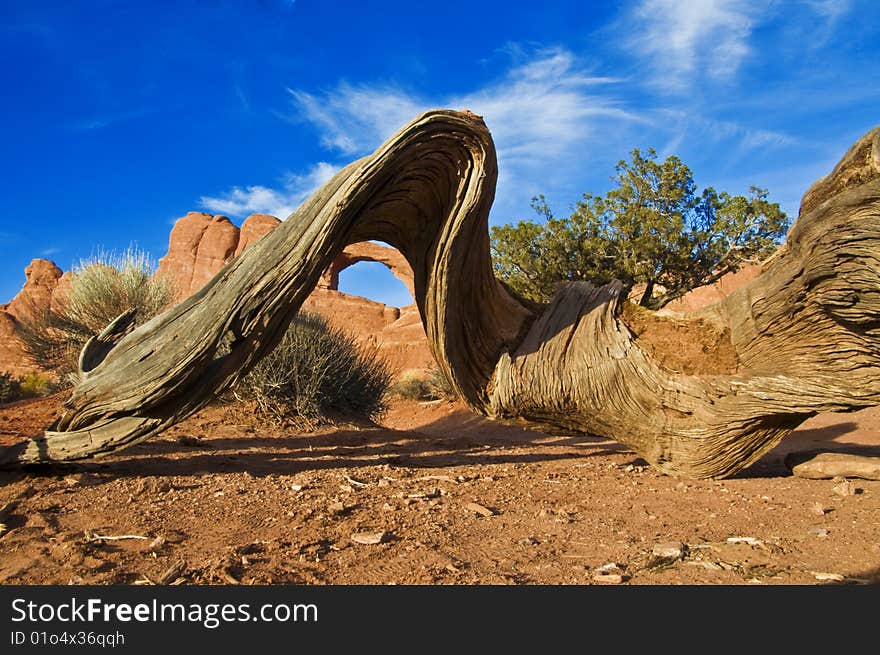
0,396 -> 880,585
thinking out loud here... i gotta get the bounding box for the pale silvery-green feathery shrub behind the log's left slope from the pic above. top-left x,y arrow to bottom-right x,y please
18,247 -> 174,383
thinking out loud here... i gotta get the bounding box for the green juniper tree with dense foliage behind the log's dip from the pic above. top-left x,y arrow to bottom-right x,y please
492,149 -> 790,309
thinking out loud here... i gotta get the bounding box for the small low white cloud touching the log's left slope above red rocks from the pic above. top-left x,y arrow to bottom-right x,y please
199,162 -> 339,219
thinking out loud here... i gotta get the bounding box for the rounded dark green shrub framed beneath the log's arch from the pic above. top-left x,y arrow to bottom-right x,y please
235,312 -> 391,428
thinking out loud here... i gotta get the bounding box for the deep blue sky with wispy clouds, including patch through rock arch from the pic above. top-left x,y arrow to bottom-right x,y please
0,0 -> 880,304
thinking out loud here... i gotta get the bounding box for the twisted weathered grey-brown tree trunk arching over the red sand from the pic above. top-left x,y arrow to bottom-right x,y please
4,111 -> 880,477
